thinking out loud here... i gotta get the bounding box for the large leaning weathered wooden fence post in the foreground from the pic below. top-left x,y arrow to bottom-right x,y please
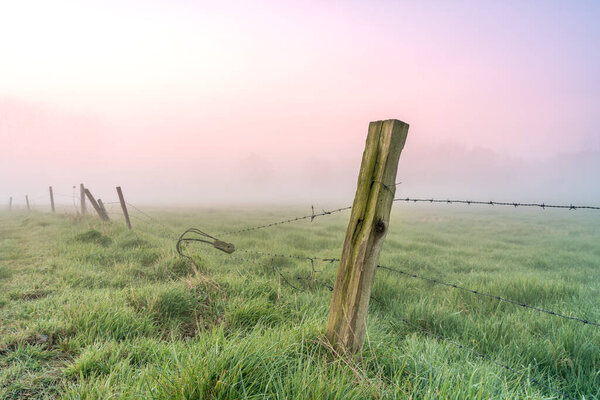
326,119 -> 408,353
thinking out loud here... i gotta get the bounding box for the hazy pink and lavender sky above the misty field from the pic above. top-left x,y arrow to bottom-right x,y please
0,0 -> 600,205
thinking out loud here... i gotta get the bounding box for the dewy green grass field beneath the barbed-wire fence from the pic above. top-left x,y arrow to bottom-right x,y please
0,204 -> 600,399
